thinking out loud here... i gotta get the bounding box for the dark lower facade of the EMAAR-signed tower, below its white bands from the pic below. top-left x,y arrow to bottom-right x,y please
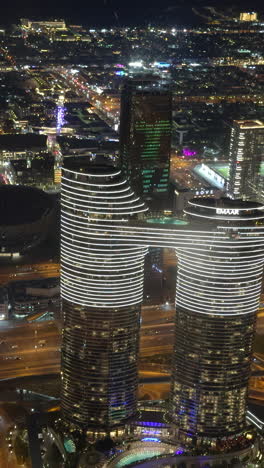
170,307 -> 255,438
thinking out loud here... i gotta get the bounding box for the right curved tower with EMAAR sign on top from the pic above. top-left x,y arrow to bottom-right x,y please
170,199 -> 264,446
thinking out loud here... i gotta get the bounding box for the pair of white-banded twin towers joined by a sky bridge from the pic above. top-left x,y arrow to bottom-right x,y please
61,158 -> 264,446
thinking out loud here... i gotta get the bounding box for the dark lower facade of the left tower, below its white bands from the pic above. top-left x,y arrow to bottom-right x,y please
62,300 -> 140,431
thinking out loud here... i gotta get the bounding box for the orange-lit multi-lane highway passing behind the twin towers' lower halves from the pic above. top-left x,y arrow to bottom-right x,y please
0,304 -> 264,398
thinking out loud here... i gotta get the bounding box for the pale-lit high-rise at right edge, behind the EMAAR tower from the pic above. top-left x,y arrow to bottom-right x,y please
228,120 -> 264,199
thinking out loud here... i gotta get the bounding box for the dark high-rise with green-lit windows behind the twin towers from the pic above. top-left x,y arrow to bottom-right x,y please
120,77 -> 172,211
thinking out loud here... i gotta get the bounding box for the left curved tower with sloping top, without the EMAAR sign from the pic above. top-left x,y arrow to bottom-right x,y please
61,157 -> 147,433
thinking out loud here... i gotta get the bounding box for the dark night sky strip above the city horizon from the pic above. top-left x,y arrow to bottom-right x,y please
0,0 -> 264,26
